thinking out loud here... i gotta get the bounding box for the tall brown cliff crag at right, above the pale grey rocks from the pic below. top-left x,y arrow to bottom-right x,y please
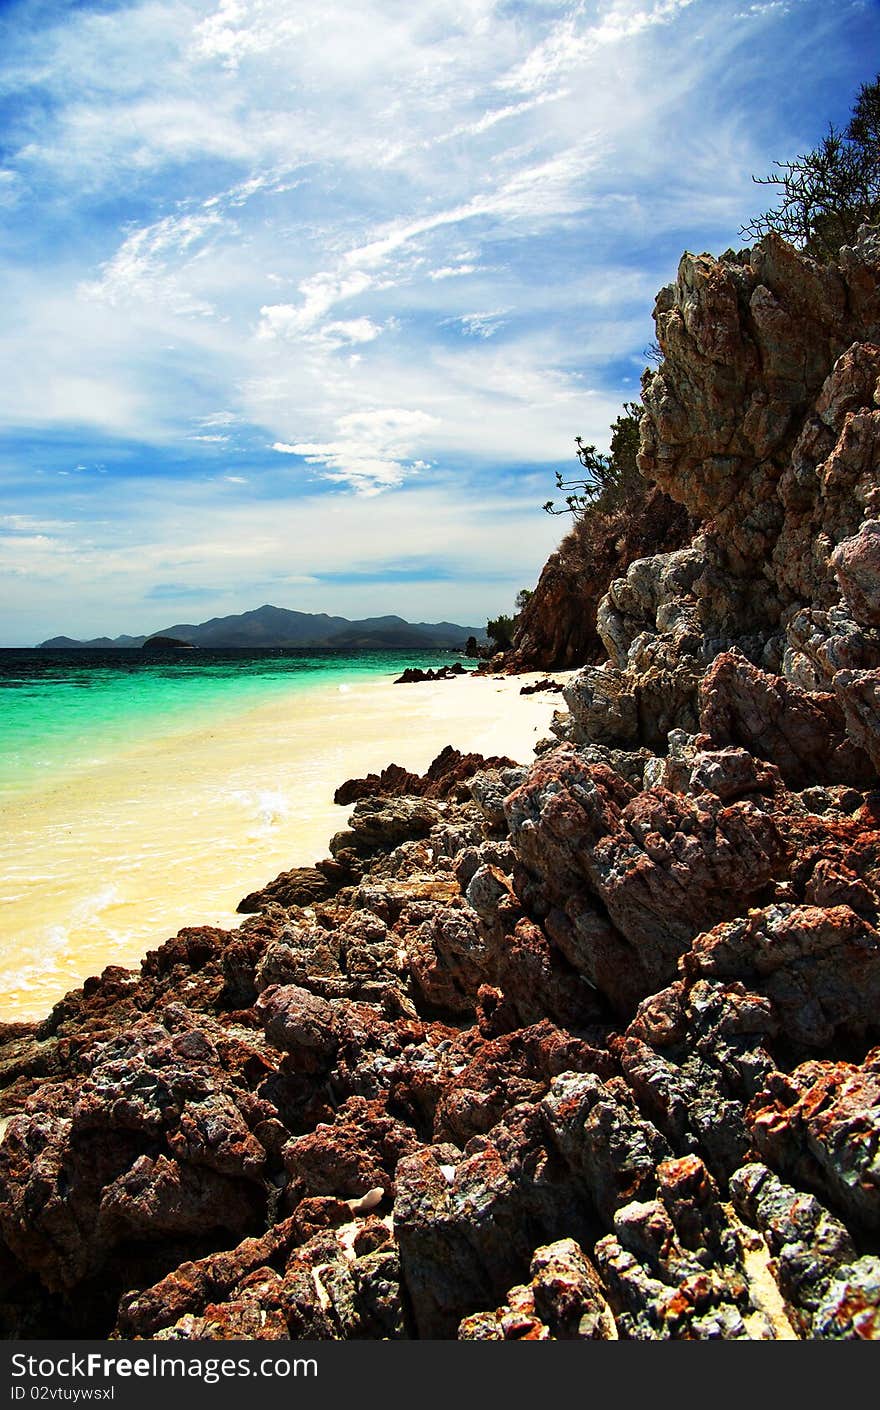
639,233 -> 880,659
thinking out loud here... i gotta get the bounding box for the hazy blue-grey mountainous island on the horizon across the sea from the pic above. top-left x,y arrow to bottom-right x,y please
37,603 -> 487,651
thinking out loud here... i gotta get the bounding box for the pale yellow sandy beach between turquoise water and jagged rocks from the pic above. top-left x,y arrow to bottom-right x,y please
0,675 -> 564,1021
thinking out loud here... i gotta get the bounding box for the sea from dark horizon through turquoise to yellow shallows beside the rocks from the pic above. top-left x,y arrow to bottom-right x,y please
0,649 -> 472,1021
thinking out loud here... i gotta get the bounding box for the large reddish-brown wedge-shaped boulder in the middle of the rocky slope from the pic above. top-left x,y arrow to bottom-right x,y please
506,750 -> 784,1011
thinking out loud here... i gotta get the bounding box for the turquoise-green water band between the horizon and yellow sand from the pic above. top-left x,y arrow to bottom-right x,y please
0,650 -> 473,799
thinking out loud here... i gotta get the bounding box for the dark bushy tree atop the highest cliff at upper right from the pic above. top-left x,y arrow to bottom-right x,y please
740,73 -> 880,259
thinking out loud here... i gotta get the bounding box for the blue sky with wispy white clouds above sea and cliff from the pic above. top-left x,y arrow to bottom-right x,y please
0,0 -> 880,646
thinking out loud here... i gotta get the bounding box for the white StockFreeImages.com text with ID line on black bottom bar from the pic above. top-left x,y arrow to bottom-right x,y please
11,1351 -> 317,1400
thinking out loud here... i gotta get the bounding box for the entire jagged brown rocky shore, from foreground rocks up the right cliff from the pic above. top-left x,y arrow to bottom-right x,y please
0,230 -> 880,1340
